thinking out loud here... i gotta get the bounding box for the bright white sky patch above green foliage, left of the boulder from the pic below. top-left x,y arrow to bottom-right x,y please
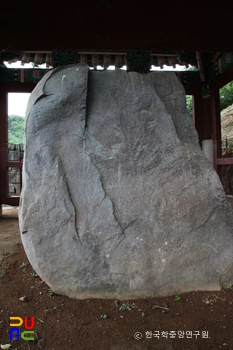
8,93 -> 30,117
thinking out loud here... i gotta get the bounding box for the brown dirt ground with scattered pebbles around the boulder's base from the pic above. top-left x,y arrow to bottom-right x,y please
0,208 -> 233,350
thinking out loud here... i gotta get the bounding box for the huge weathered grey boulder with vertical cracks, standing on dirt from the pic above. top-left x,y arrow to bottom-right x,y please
20,65 -> 233,298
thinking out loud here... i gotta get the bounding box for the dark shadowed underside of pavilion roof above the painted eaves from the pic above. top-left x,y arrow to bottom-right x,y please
0,0 -> 233,52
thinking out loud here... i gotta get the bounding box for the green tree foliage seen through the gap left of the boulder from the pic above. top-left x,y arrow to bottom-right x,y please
8,115 -> 24,144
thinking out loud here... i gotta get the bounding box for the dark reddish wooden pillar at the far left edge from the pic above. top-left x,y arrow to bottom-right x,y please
0,87 -> 9,214
